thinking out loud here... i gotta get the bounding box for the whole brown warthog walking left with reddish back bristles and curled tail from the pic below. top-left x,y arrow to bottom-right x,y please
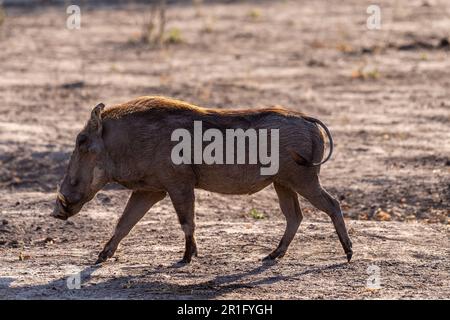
52,97 -> 352,263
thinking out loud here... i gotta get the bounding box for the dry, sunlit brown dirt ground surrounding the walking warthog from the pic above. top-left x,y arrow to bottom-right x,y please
0,0 -> 450,299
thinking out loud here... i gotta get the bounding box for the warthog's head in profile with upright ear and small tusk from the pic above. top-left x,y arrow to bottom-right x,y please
52,104 -> 108,220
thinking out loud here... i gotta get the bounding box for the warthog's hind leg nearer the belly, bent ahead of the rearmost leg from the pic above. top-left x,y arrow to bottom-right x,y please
264,183 -> 303,260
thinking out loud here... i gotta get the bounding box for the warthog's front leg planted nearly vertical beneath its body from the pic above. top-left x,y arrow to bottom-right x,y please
169,187 -> 197,263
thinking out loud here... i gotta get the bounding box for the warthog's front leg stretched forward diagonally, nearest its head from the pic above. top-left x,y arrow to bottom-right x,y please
96,191 -> 166,263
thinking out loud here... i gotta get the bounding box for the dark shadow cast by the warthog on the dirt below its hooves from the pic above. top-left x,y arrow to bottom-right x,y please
0,262 -> 348,299
